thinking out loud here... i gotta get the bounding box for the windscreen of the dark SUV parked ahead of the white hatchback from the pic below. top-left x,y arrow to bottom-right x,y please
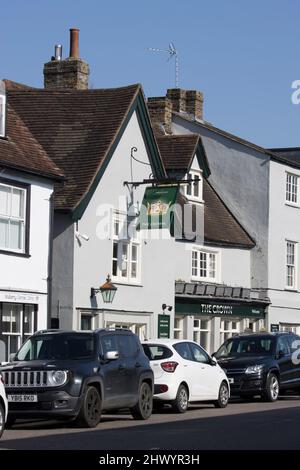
215,337 -> 274,359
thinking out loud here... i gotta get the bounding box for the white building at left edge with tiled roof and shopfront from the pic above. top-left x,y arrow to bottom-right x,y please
0,80 -> 63,362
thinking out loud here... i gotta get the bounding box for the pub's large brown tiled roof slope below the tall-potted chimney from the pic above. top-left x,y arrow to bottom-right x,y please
7,85 -> 141,210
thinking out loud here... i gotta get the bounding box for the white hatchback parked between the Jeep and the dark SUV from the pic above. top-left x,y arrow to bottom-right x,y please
143,339 -> 230,413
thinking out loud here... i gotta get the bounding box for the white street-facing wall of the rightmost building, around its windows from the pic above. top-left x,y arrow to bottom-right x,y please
268,161 -> 300,325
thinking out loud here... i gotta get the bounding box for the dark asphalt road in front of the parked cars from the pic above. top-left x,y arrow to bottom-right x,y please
0,396 -> 300,450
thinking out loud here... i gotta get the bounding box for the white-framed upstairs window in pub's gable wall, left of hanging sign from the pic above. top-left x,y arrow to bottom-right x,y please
112,213 -> 141,284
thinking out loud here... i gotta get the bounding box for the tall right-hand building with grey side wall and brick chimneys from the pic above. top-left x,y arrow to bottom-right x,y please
150,89 -> 300,333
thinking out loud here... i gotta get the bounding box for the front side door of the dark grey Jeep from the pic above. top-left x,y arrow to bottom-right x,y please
100,333 -> 127,408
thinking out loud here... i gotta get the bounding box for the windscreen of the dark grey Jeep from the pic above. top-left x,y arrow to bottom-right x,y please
16,333 -> 95,361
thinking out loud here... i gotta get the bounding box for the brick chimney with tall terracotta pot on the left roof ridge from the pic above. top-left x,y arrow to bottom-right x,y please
44,28 -> 90,90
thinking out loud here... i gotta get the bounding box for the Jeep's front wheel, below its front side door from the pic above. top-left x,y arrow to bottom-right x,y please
77,386 -> 102,428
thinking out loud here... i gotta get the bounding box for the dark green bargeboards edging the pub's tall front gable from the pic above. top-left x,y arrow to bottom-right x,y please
72,90 -> 165,221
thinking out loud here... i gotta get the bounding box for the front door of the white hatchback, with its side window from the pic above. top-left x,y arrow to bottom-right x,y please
188,343 -> 220,400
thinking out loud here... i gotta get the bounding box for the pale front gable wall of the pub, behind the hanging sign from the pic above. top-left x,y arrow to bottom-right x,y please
73,113 -> 175,336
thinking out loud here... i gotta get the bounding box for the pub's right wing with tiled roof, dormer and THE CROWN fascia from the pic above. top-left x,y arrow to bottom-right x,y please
152,130 -> 269,352
